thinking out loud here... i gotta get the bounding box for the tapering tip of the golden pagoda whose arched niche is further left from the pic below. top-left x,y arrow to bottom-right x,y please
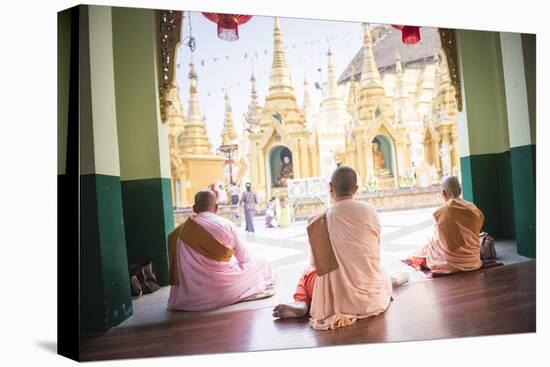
269,17 -> 294,96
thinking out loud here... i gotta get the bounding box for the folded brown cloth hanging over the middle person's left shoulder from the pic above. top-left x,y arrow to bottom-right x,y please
307,212 -> 338,275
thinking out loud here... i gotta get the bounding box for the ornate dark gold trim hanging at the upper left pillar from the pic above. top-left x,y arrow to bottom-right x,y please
157,10 -> 183,123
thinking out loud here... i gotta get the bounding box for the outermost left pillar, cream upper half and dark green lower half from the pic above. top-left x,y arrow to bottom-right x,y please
78,6 -> 132,335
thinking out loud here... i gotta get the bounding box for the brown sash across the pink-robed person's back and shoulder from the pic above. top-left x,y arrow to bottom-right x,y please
168,218 -> 234,285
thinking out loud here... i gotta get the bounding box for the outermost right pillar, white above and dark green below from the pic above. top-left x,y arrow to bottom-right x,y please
500,33 -> 536,257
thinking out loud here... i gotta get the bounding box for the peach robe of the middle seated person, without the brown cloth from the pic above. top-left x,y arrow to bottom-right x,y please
310,199 -> 392,330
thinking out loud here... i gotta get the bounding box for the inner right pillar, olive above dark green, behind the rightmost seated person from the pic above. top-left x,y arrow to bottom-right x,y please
457,30 -> 515,238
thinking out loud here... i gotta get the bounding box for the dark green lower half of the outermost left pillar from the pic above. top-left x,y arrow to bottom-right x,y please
80,174 -> 132,334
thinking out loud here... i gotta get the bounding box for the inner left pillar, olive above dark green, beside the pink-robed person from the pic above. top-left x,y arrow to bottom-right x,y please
112,7 -> 174,285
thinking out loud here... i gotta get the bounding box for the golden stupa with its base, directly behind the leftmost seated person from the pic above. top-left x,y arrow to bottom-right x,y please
173,64 -> 225,206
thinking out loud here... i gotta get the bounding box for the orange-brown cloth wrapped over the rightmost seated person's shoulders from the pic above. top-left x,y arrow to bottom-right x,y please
434,199 -> 484,251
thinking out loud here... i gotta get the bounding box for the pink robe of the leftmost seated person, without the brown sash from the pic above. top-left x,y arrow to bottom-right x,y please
168,212 -> 274,311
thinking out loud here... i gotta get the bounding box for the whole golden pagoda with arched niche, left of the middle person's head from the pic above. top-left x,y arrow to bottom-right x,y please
249,17 -> 319,201
